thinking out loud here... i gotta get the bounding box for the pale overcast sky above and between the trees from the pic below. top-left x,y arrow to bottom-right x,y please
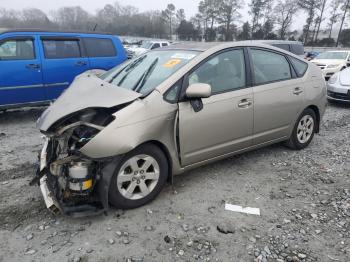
0,0 -> 305,30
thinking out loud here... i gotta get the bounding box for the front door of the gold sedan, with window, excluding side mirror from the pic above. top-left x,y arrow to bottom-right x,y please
179,49 -> 254,166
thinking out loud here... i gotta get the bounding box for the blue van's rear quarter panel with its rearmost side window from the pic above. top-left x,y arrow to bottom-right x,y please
83,37 -> 125,70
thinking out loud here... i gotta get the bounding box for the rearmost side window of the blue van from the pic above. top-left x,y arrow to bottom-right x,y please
84,38 -> 117,57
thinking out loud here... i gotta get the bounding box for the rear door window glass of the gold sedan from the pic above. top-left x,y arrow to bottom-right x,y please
251,49 -> 292,85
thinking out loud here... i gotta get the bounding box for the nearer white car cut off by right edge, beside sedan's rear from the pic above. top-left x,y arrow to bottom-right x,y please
327,67 -> 350,102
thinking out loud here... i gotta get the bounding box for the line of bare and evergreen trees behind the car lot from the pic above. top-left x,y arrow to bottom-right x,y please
0,0 -> 350,46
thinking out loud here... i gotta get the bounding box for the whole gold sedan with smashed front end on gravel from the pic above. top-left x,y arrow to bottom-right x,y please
32,42 -> 326,216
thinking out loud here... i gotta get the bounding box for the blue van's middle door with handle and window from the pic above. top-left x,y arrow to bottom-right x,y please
40,36 -> 89,100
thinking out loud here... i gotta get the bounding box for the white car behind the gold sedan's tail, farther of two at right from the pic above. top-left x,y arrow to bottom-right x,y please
311,50 -> 350,79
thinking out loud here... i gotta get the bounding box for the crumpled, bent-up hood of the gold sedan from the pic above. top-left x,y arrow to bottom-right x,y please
37,73 -> 141,131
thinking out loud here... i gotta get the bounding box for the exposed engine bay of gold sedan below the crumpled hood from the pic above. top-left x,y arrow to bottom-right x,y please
35,108 -> 117,215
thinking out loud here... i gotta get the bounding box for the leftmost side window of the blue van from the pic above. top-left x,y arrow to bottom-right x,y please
0,39 -> 35,60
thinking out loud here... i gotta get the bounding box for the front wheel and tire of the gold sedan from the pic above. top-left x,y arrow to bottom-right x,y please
109,144 -> 169,209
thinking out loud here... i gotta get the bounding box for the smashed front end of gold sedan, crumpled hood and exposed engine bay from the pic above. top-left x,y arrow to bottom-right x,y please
31,75 -> 140,216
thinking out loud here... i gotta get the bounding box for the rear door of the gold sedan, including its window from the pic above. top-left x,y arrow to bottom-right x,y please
250,48 -> 305,144
